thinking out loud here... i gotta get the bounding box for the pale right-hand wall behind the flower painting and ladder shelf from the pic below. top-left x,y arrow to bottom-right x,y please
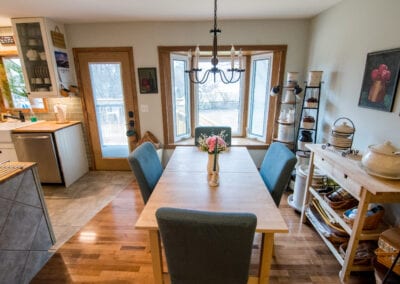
308,0 -> 400,224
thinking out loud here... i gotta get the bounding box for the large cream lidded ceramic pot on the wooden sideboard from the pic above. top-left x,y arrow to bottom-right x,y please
361,141 -> 400,178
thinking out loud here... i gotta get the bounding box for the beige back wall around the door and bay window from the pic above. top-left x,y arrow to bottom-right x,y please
65,20 -> 309,150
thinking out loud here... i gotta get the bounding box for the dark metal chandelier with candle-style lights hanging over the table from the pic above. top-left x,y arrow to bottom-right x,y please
185,0 -> 245,84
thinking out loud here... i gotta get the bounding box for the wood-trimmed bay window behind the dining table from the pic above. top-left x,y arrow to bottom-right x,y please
159,46 -> 287,148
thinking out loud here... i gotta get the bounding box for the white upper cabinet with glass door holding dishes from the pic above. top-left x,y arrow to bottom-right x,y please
11,18 -> 76,98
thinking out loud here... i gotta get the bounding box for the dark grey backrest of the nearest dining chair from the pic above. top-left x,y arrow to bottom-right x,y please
156,207 -> 257,284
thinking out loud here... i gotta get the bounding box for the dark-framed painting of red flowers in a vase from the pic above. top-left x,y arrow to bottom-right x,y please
358,48 -> 400,112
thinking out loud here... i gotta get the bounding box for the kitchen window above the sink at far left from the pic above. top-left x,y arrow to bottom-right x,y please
2,57 -> 44,108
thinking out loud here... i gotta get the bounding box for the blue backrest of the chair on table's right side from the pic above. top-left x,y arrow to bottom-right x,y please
260,142 -> 297,206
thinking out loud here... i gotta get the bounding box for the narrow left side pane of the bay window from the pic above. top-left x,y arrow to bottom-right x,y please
172,56 -> 190,141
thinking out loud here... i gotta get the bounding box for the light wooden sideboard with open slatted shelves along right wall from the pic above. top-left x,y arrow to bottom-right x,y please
301,144 -> 400,282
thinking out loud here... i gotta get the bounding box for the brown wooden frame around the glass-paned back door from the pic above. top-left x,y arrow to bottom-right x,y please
72,47 -> 141,170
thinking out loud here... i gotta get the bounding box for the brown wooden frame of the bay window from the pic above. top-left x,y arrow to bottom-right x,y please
158,45 -> 287,149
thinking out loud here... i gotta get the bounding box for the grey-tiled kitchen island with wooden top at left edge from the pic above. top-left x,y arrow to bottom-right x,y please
0,162 -> 56,283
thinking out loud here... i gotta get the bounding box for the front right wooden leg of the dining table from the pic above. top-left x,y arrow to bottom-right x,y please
258,233 -> 274,284
